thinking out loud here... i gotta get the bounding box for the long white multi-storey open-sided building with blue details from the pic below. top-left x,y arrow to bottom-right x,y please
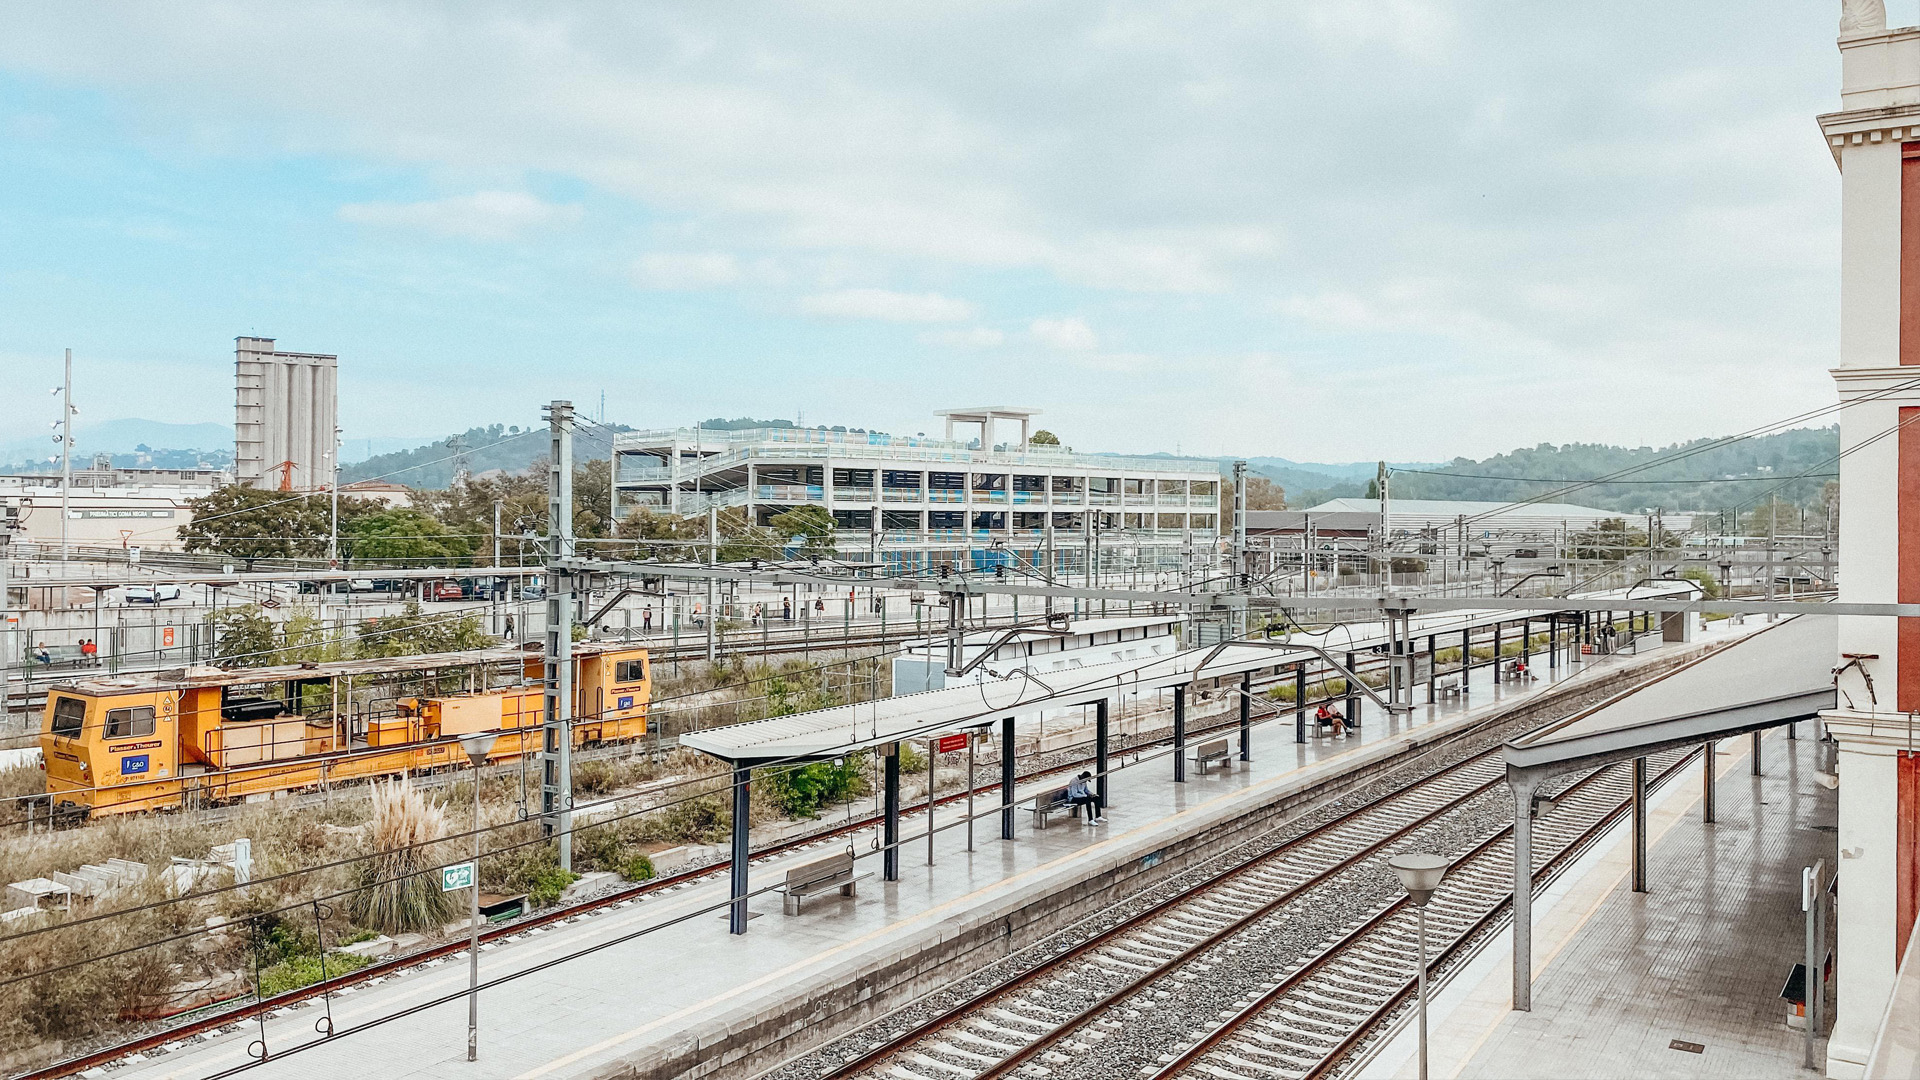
612,405 -> 1221,571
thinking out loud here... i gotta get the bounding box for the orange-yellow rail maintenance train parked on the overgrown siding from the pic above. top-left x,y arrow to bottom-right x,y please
40,642 -> 653,817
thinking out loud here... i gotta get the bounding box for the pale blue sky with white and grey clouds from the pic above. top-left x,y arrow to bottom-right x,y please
0,0 -> 1873,461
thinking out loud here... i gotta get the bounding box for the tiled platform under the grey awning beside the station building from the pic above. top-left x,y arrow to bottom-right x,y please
1359,711 -> 1837,1080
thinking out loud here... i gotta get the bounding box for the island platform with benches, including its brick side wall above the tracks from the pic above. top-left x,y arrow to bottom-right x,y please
93,626 -> 1743,1080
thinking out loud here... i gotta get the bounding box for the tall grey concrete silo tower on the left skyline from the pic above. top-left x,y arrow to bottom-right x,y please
234,336 -> 340,490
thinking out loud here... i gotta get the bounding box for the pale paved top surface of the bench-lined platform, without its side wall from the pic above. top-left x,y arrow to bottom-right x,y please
113,630 -> 1732,1080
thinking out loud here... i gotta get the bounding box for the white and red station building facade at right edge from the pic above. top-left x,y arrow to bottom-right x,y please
1820,0 -> 1920,1078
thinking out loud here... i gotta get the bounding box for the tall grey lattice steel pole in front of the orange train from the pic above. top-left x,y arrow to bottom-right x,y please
540,402 -> 574,871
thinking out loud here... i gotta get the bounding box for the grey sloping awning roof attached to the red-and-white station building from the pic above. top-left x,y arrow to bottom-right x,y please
1505,615 -> 1839,774
